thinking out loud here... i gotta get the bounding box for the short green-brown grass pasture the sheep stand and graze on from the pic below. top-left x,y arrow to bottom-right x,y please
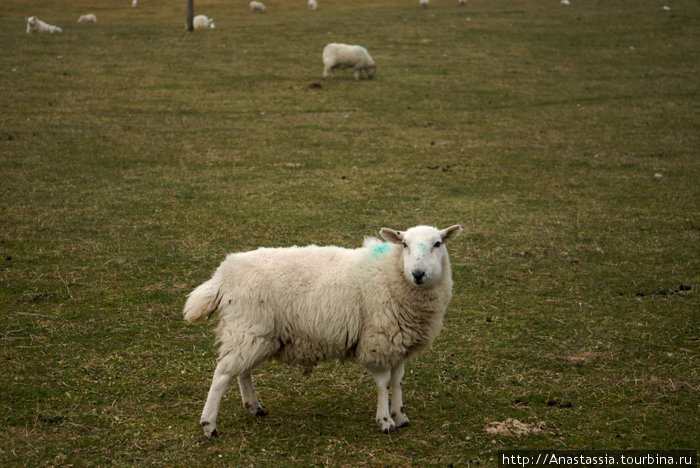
0,0 -> 700,466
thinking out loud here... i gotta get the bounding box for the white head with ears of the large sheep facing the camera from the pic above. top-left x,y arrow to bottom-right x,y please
380,225 -> 462,287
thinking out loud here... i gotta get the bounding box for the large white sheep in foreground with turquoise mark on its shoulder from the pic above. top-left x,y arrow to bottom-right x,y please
184,225 -> 462,437
